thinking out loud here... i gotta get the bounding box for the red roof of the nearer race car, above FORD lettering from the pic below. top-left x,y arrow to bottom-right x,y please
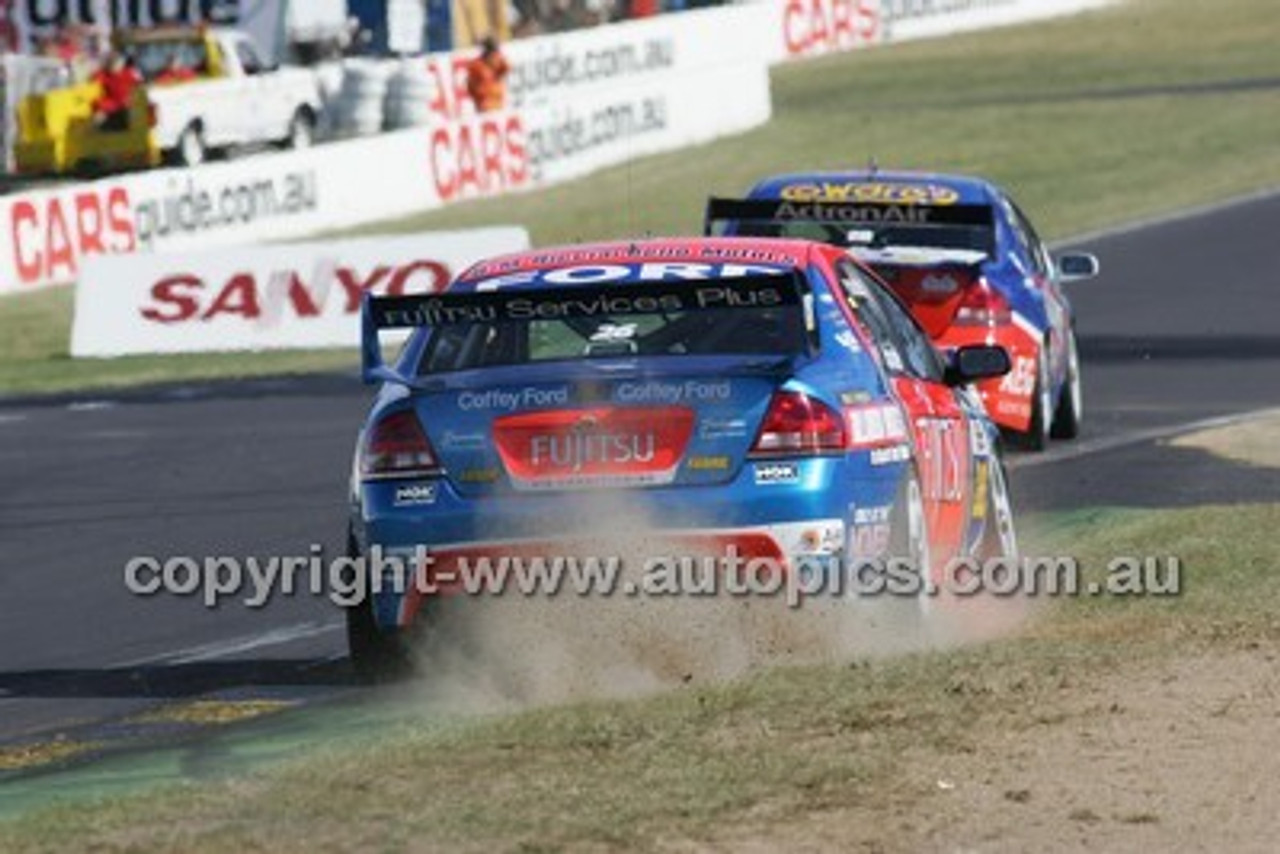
449,237 -> 820,291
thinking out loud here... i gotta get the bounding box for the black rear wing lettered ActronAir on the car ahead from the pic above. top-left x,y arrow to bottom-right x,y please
703,196 -> 995,236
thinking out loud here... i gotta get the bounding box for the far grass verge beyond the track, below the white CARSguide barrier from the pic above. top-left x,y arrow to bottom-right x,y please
0,0 -> 1280,393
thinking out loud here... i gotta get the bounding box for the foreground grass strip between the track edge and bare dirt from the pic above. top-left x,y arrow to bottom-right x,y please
0,506 -> 1280,854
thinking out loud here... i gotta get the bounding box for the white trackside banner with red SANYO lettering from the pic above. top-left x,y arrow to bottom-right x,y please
72,227 -> 529,356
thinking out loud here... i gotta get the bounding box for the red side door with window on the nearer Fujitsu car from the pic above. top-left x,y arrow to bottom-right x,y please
835,259 -> 972,557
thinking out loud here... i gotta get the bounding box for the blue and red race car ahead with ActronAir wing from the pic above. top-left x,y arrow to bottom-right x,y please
705,170 -> 1098,451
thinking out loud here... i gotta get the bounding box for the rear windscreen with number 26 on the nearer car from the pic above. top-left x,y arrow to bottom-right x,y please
417,305 -> 806,375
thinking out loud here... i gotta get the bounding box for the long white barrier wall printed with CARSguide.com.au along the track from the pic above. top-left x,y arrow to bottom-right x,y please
0,0 -> 1108,302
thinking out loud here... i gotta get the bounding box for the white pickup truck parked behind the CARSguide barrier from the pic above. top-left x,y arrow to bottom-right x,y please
118,27 -> 321,166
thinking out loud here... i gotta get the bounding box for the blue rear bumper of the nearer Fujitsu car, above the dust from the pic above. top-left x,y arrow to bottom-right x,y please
353,455 -> 908,629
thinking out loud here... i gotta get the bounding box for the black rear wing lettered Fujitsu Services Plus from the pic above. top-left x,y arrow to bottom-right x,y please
361,275 -> 817,384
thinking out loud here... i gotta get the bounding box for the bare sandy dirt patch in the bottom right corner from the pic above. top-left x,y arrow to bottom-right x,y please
711,648 -> 1280,853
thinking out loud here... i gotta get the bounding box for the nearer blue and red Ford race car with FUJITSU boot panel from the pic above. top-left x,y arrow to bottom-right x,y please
347,238 -> 1016,675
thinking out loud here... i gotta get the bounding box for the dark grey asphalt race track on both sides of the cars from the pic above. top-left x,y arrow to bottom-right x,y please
0,195 -> 1280,744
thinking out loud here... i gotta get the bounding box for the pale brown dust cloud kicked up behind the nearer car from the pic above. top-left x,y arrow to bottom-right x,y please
404,497 -> 1025,713
